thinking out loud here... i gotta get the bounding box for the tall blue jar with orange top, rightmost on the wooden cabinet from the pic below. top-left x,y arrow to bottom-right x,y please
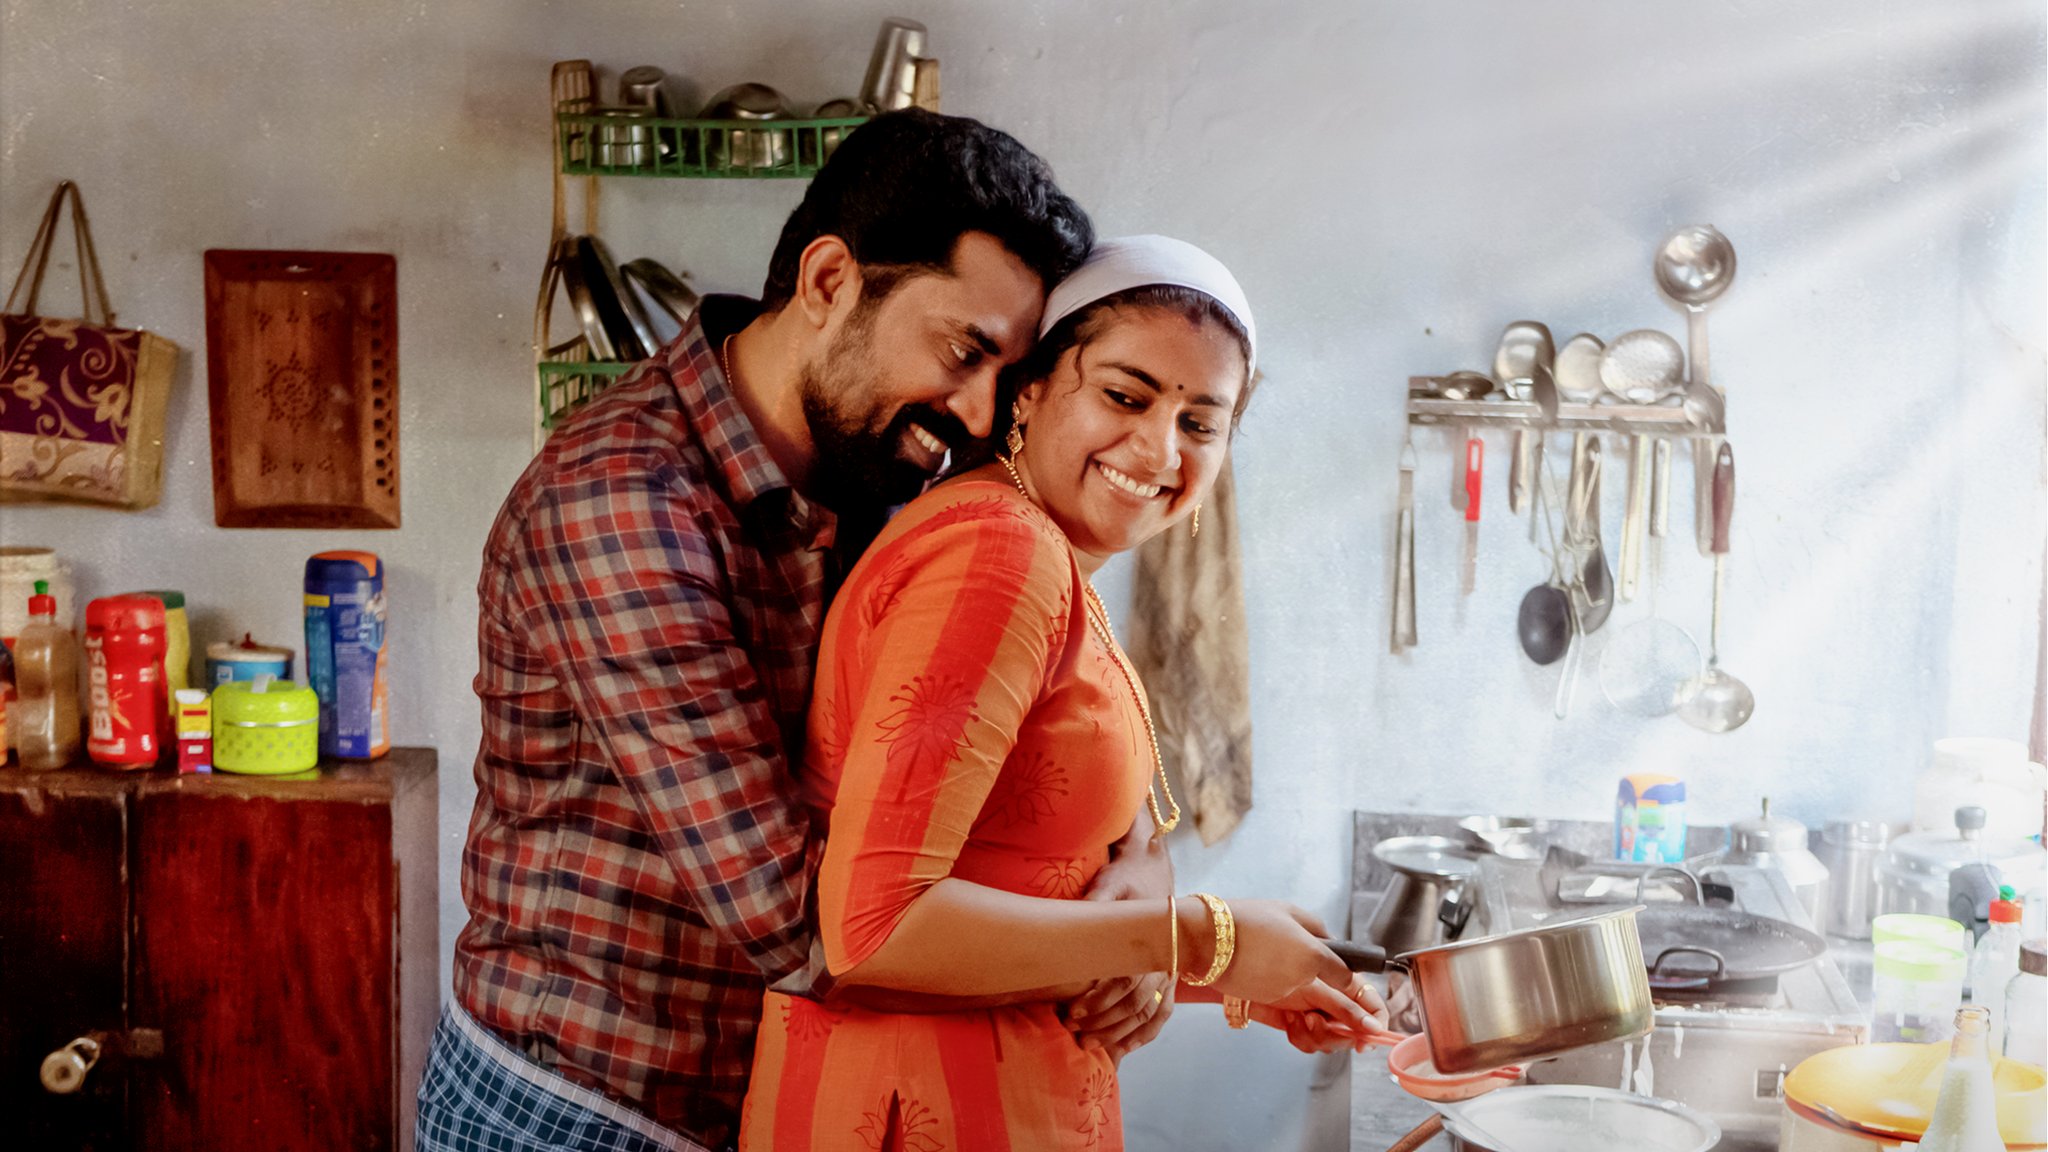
305,551 -> 391,760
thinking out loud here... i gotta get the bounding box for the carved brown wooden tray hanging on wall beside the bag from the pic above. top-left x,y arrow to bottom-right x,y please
207,248 -> 399,529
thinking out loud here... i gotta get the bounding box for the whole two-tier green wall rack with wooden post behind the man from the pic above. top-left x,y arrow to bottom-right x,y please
532,59 -> 866,453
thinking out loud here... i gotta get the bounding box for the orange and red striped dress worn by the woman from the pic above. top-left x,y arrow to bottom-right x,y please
739,480 -> 1151,1152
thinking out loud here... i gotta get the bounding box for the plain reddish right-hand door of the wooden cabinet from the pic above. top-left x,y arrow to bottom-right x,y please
131,783 -> 397,1152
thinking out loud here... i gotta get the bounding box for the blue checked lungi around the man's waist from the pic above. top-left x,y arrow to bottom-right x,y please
414,1006 -> 709,1152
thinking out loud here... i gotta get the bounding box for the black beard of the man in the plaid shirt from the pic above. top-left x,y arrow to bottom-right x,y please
799,316 -> 969,515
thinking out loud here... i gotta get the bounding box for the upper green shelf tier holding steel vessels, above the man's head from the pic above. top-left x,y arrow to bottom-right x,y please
555,109 -> 868,180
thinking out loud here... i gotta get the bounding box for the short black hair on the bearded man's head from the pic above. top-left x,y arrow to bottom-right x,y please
762,109 -> 1096,312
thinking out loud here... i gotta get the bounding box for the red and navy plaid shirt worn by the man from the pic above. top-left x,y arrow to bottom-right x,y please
455,297 -> 836,1144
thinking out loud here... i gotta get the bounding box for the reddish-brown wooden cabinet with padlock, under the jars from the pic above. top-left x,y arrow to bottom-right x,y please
0,748 -> 440,1152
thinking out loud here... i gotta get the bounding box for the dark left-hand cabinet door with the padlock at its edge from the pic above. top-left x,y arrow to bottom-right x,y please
0,773 -> 129,1152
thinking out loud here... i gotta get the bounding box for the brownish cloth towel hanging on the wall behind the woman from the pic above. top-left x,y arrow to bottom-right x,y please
1130,461 -> 1251,845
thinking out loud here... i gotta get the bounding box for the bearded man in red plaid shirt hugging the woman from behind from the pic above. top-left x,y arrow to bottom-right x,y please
418,111 -> 1165,1150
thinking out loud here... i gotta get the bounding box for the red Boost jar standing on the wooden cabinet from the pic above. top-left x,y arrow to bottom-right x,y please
84,596 -> 170,769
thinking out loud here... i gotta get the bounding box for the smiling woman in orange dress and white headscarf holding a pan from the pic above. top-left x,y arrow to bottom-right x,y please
739,236 -> 1378,1152
